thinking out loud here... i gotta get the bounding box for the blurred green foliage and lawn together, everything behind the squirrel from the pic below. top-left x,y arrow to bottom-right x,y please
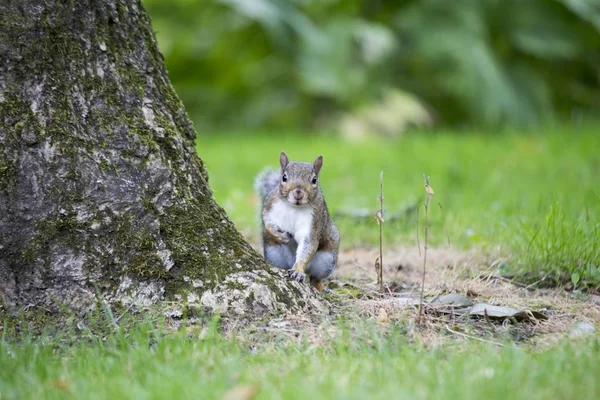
144,0 -> 600,290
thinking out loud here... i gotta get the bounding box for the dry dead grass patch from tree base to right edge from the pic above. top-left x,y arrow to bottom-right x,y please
241,242 -> 600,347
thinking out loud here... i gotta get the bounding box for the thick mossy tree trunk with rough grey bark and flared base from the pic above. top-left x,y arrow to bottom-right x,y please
0,0 -> 319,318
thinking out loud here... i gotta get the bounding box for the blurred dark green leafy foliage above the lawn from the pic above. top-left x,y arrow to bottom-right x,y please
144,0 -> 600,135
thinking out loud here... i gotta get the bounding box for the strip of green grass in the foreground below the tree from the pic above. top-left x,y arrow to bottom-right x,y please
0,325 -> 600,400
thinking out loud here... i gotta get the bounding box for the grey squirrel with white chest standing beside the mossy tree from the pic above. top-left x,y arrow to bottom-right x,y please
255,152 -> 340,292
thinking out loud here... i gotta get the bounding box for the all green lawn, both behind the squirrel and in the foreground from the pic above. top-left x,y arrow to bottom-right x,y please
0,128 -> 600,400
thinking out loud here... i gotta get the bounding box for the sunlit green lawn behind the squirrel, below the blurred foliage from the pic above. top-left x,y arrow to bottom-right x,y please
198,126 -> 600,287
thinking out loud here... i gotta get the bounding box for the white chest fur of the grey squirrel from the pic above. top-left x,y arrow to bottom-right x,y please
266,199 -> 313,243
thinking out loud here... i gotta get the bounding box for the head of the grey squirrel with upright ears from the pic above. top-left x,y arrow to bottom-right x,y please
279,152 -> 323,206
